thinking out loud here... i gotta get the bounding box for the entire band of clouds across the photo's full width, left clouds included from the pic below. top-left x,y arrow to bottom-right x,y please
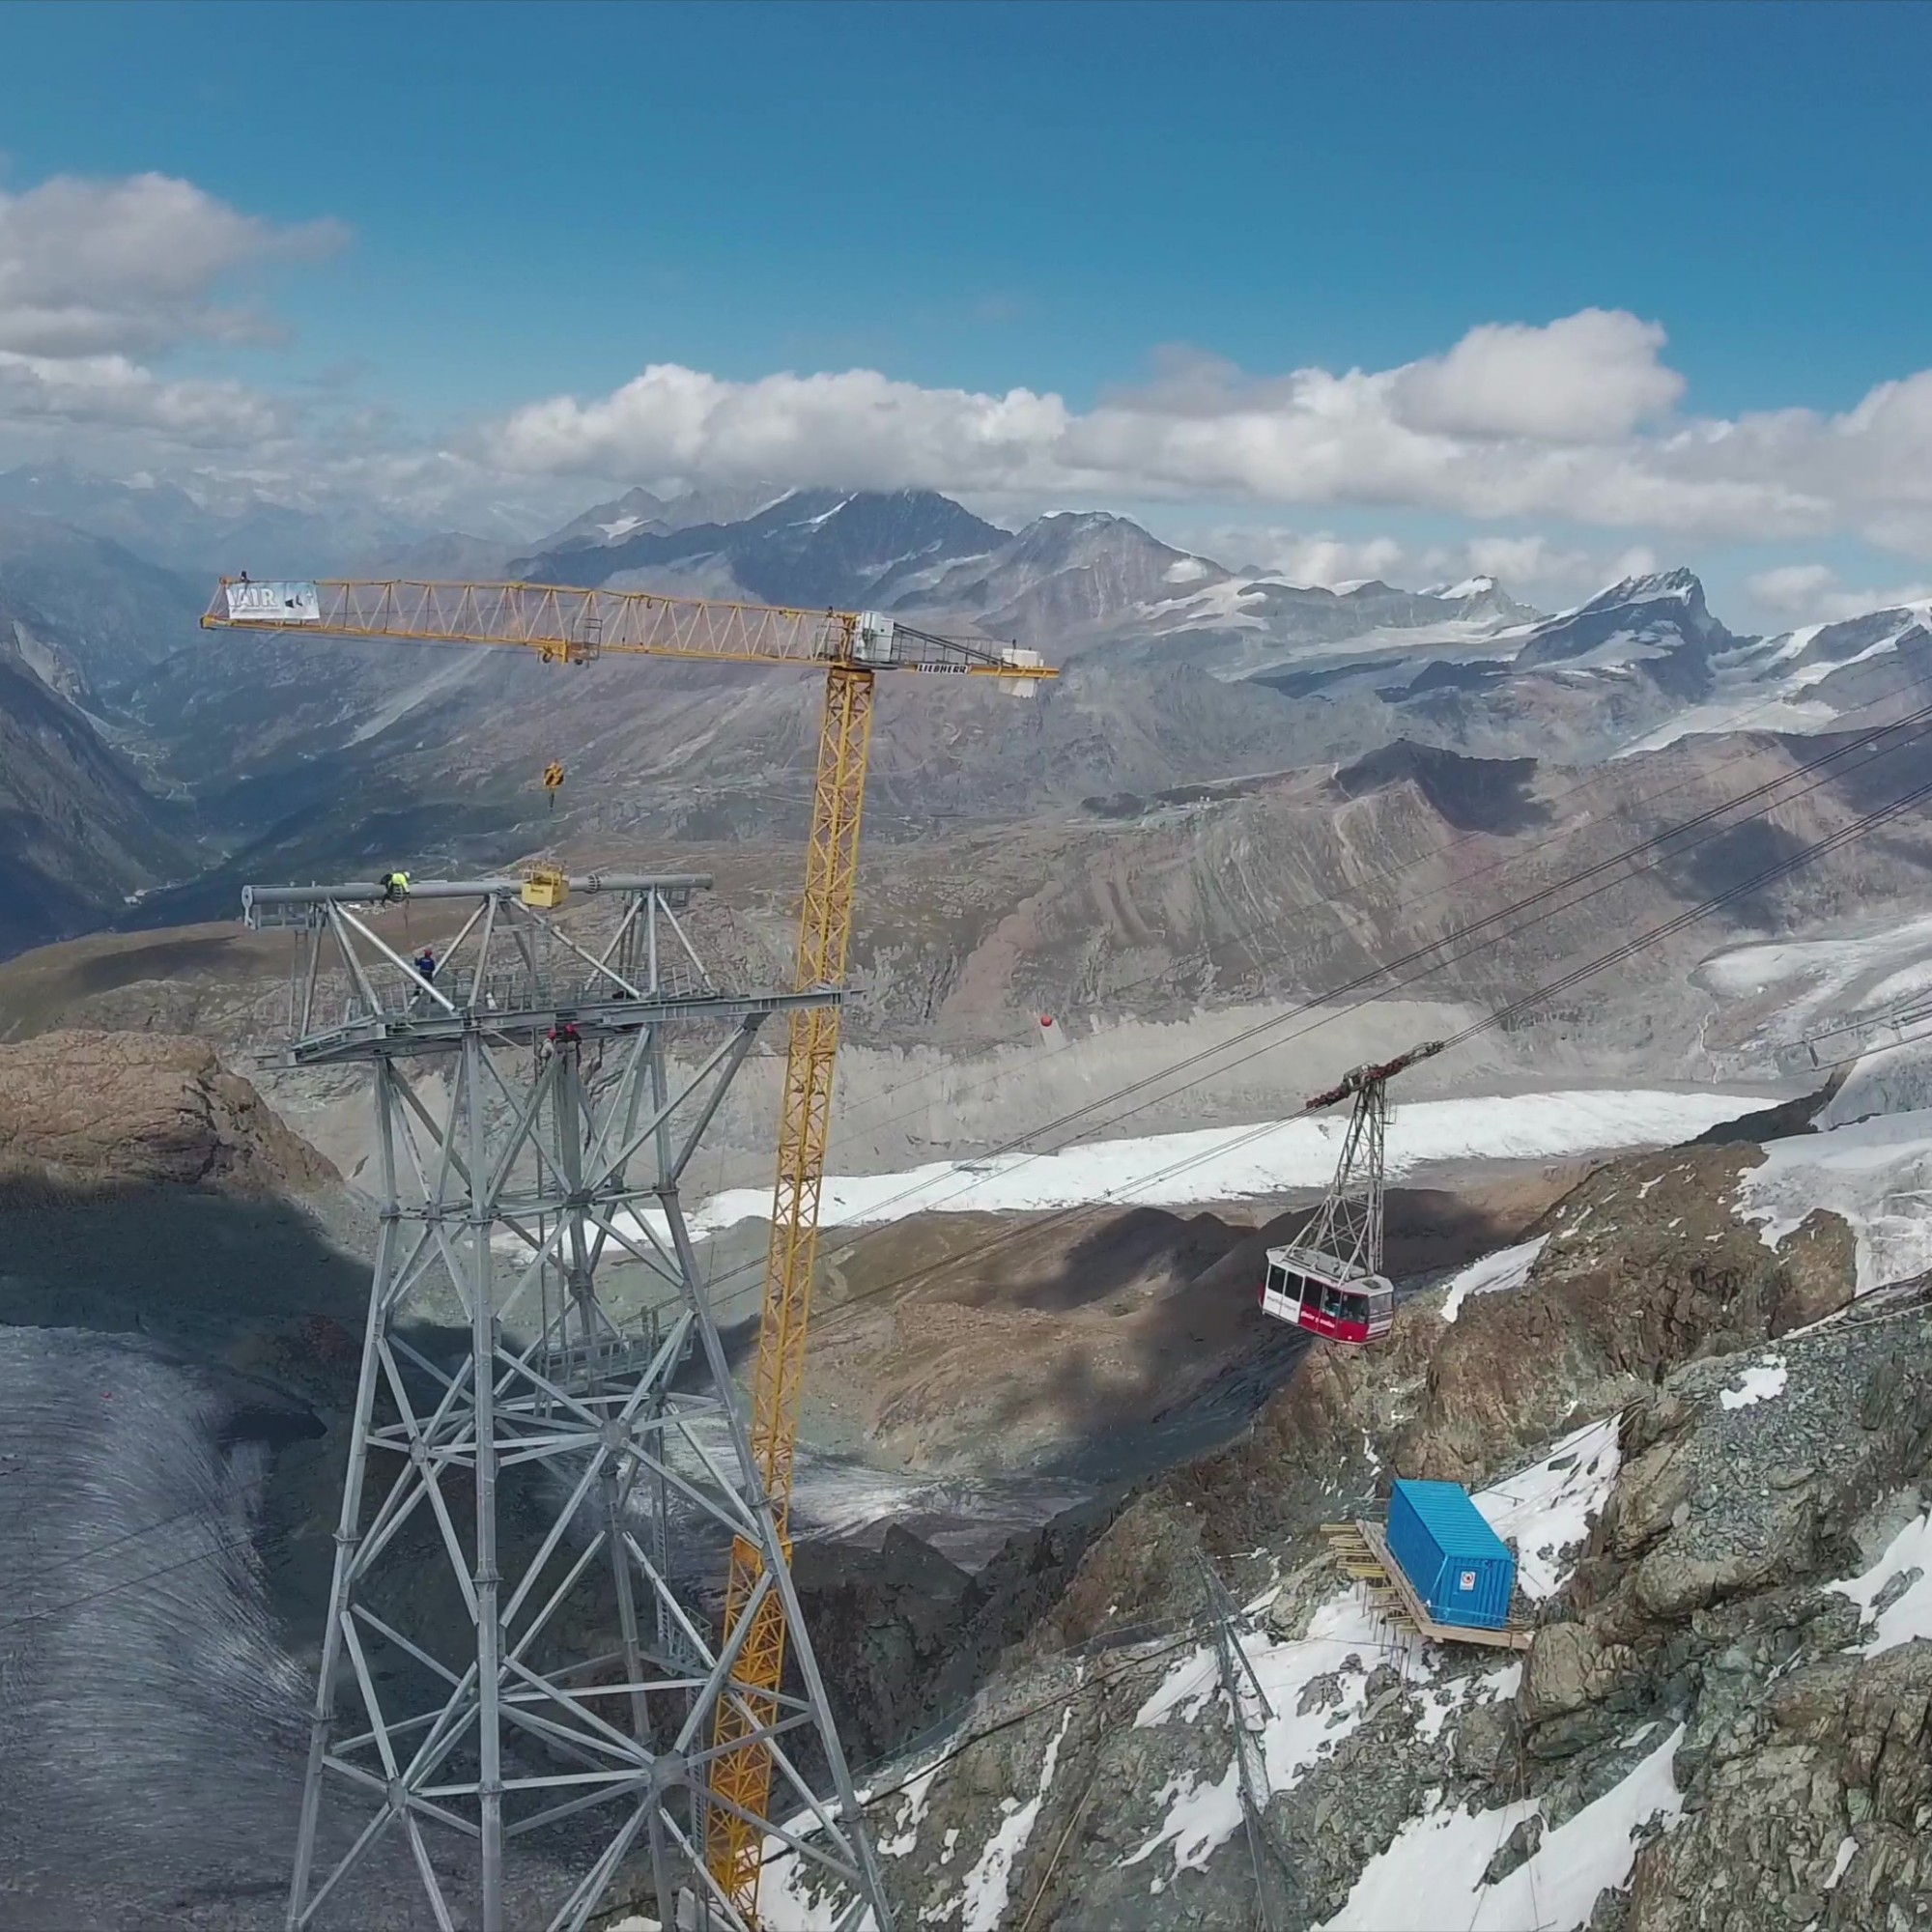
0,174 -> 1932,605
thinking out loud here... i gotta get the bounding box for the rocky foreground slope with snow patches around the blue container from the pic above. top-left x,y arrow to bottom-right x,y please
750,1097 -> 1932,1932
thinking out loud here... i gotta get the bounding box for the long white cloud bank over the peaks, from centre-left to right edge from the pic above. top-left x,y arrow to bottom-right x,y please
481,309 -> 1932,554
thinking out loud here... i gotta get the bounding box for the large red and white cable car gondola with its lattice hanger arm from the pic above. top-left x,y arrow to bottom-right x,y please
1262,1039 -> 1443,1347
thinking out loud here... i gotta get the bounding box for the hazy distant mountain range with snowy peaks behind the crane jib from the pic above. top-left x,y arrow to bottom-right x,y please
0,471 -> 1932,951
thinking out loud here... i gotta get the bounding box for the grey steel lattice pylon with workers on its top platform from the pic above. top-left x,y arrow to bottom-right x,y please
245,877 -> 889,1932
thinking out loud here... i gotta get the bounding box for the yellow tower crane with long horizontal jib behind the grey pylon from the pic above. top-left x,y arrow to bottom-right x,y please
201,576 -> 1057,1922
